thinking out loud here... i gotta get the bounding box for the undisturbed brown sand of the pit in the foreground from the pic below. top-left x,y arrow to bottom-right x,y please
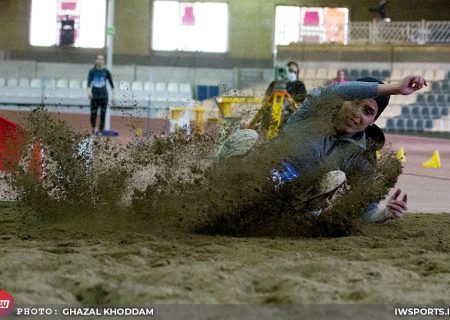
0,202 -> 450,305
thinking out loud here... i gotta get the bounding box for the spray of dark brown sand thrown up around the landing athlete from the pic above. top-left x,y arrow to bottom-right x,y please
8,100 -> 401,237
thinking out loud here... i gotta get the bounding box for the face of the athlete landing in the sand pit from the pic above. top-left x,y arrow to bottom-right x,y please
335,99 -> 378,134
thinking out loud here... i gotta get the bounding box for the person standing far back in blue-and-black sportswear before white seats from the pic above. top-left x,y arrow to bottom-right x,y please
87,54 -> 114,134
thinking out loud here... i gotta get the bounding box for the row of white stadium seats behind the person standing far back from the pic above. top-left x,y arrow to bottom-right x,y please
0,78 -> 193,108
